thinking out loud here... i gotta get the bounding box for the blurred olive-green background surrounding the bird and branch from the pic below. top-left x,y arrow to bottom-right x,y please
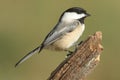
0,0 -> 120,80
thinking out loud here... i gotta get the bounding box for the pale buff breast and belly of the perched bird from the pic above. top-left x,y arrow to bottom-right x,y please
53,24 -> 85,50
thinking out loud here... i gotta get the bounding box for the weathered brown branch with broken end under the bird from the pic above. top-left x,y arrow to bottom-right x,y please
48,32 -> 103,80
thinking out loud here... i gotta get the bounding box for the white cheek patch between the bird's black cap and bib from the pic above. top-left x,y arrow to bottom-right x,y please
61,12 -> 86,21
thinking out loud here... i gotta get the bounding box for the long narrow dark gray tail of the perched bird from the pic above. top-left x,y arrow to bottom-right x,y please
15,46 -> 43,67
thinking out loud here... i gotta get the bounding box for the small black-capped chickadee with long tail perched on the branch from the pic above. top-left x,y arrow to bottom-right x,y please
15,7 -> 90,67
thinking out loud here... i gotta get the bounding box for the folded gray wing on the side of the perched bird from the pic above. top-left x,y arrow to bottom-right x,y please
43,21 -> 79,46
